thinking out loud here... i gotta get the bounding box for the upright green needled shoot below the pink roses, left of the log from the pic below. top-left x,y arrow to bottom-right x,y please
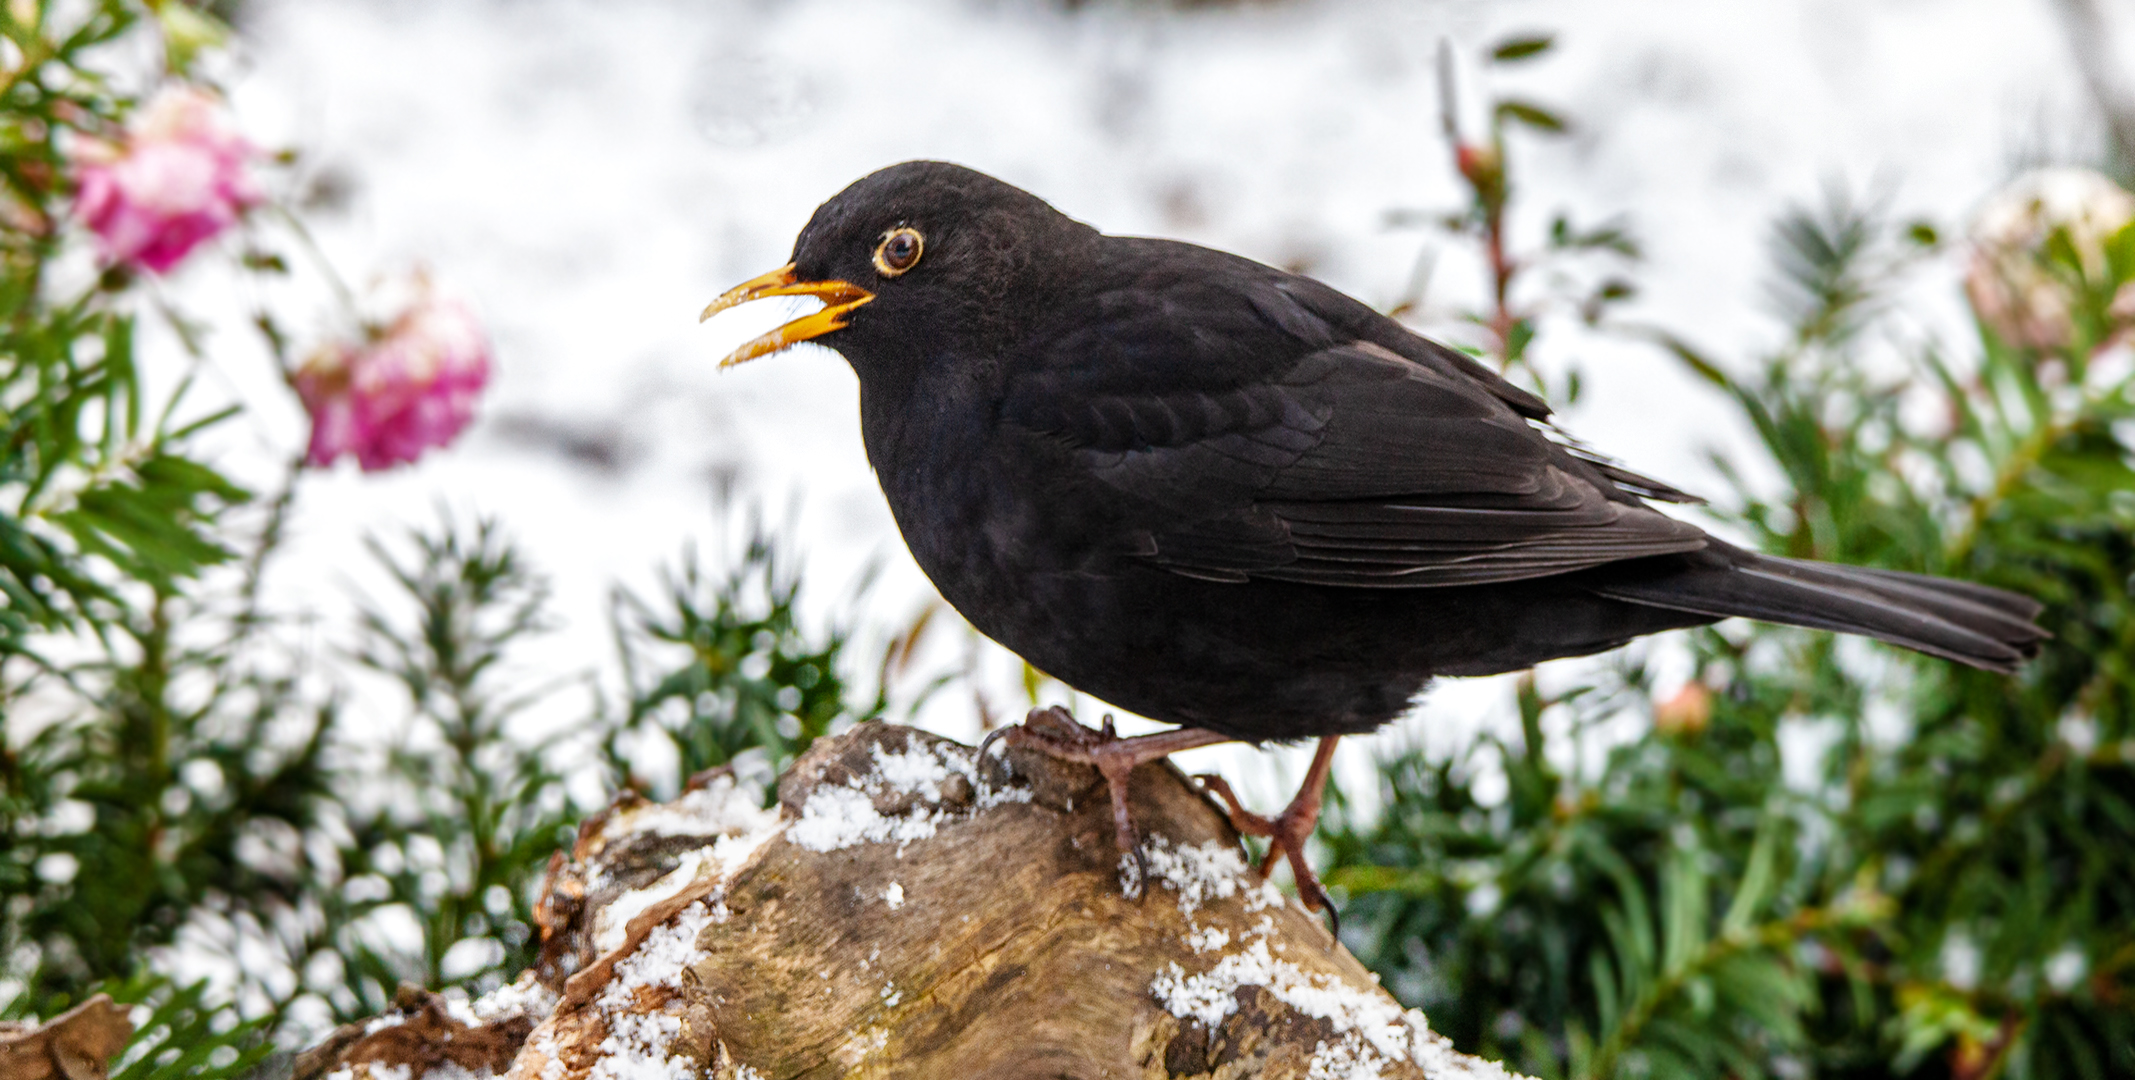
314,519 -> 587,1018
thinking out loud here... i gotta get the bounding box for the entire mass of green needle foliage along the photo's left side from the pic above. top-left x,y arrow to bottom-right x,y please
0,0 -> 882,1058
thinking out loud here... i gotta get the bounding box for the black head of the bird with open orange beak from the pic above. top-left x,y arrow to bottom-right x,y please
705,162 -> 1097,382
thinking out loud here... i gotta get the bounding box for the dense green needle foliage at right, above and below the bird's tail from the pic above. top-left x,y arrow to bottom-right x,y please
1324,101 -> 2135,1078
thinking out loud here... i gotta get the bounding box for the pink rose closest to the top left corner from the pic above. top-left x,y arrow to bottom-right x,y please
68,85 -> 260,273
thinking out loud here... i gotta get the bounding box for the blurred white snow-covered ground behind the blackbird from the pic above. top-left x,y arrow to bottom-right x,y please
173,0 -> 2135,805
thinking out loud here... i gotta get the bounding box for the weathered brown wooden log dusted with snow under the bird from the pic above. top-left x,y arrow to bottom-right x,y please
295,724 -> 1505,1080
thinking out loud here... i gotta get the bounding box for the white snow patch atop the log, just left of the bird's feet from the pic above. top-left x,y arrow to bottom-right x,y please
786,741 -> 1031,852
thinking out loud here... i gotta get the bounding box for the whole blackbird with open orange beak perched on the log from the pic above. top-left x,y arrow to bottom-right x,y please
705,162 -> 2045,907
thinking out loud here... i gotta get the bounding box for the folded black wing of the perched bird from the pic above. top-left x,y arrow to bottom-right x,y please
1003,250 -> 1706,587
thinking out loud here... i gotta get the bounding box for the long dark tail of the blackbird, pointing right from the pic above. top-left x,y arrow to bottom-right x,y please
1593,542 -> 2047,672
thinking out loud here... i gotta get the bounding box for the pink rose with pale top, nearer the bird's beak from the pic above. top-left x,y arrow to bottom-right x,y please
292,290 -> 489,472
